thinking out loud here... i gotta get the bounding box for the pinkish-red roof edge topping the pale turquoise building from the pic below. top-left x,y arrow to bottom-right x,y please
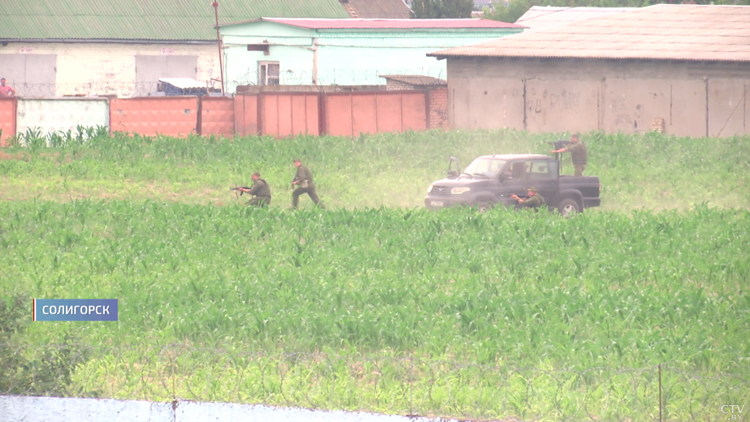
222,18 -> 523,29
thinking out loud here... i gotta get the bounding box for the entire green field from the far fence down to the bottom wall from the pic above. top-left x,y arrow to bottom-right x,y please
0,132 -> 750,421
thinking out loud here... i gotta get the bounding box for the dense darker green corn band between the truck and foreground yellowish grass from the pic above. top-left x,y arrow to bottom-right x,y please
0,200 -> 750,356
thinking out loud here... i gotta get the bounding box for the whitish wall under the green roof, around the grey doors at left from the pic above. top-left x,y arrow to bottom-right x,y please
0,42 -> 220,97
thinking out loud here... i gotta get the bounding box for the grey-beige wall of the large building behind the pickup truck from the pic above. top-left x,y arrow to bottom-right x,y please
448,59 -> 750,136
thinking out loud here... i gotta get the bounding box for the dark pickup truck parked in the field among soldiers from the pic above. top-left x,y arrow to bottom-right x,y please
424,154 -> 601,216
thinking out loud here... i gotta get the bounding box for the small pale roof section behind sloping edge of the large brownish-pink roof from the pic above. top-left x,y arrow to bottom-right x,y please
516,6 -> 638,30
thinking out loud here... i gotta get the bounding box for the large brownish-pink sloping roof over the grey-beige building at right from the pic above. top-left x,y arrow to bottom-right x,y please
428,4 -> 750,62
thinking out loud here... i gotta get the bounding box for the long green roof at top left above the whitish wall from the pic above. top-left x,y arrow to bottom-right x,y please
0,0 -> 349,41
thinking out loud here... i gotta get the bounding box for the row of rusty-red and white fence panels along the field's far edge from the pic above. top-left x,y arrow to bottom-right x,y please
0,91 -> 438,141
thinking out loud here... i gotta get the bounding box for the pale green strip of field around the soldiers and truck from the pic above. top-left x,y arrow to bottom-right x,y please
0,131 -> 750,210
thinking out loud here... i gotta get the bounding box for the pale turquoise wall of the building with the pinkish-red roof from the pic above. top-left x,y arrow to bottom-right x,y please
221,22 -> 520,92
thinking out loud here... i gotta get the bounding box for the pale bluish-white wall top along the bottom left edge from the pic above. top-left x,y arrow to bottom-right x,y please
0,396 -> 457,422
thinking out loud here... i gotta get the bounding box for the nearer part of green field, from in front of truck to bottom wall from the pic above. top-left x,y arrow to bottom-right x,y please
0,201 -> 750,420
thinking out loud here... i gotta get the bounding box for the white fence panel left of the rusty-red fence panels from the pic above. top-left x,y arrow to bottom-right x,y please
16,98 -> 109,135
